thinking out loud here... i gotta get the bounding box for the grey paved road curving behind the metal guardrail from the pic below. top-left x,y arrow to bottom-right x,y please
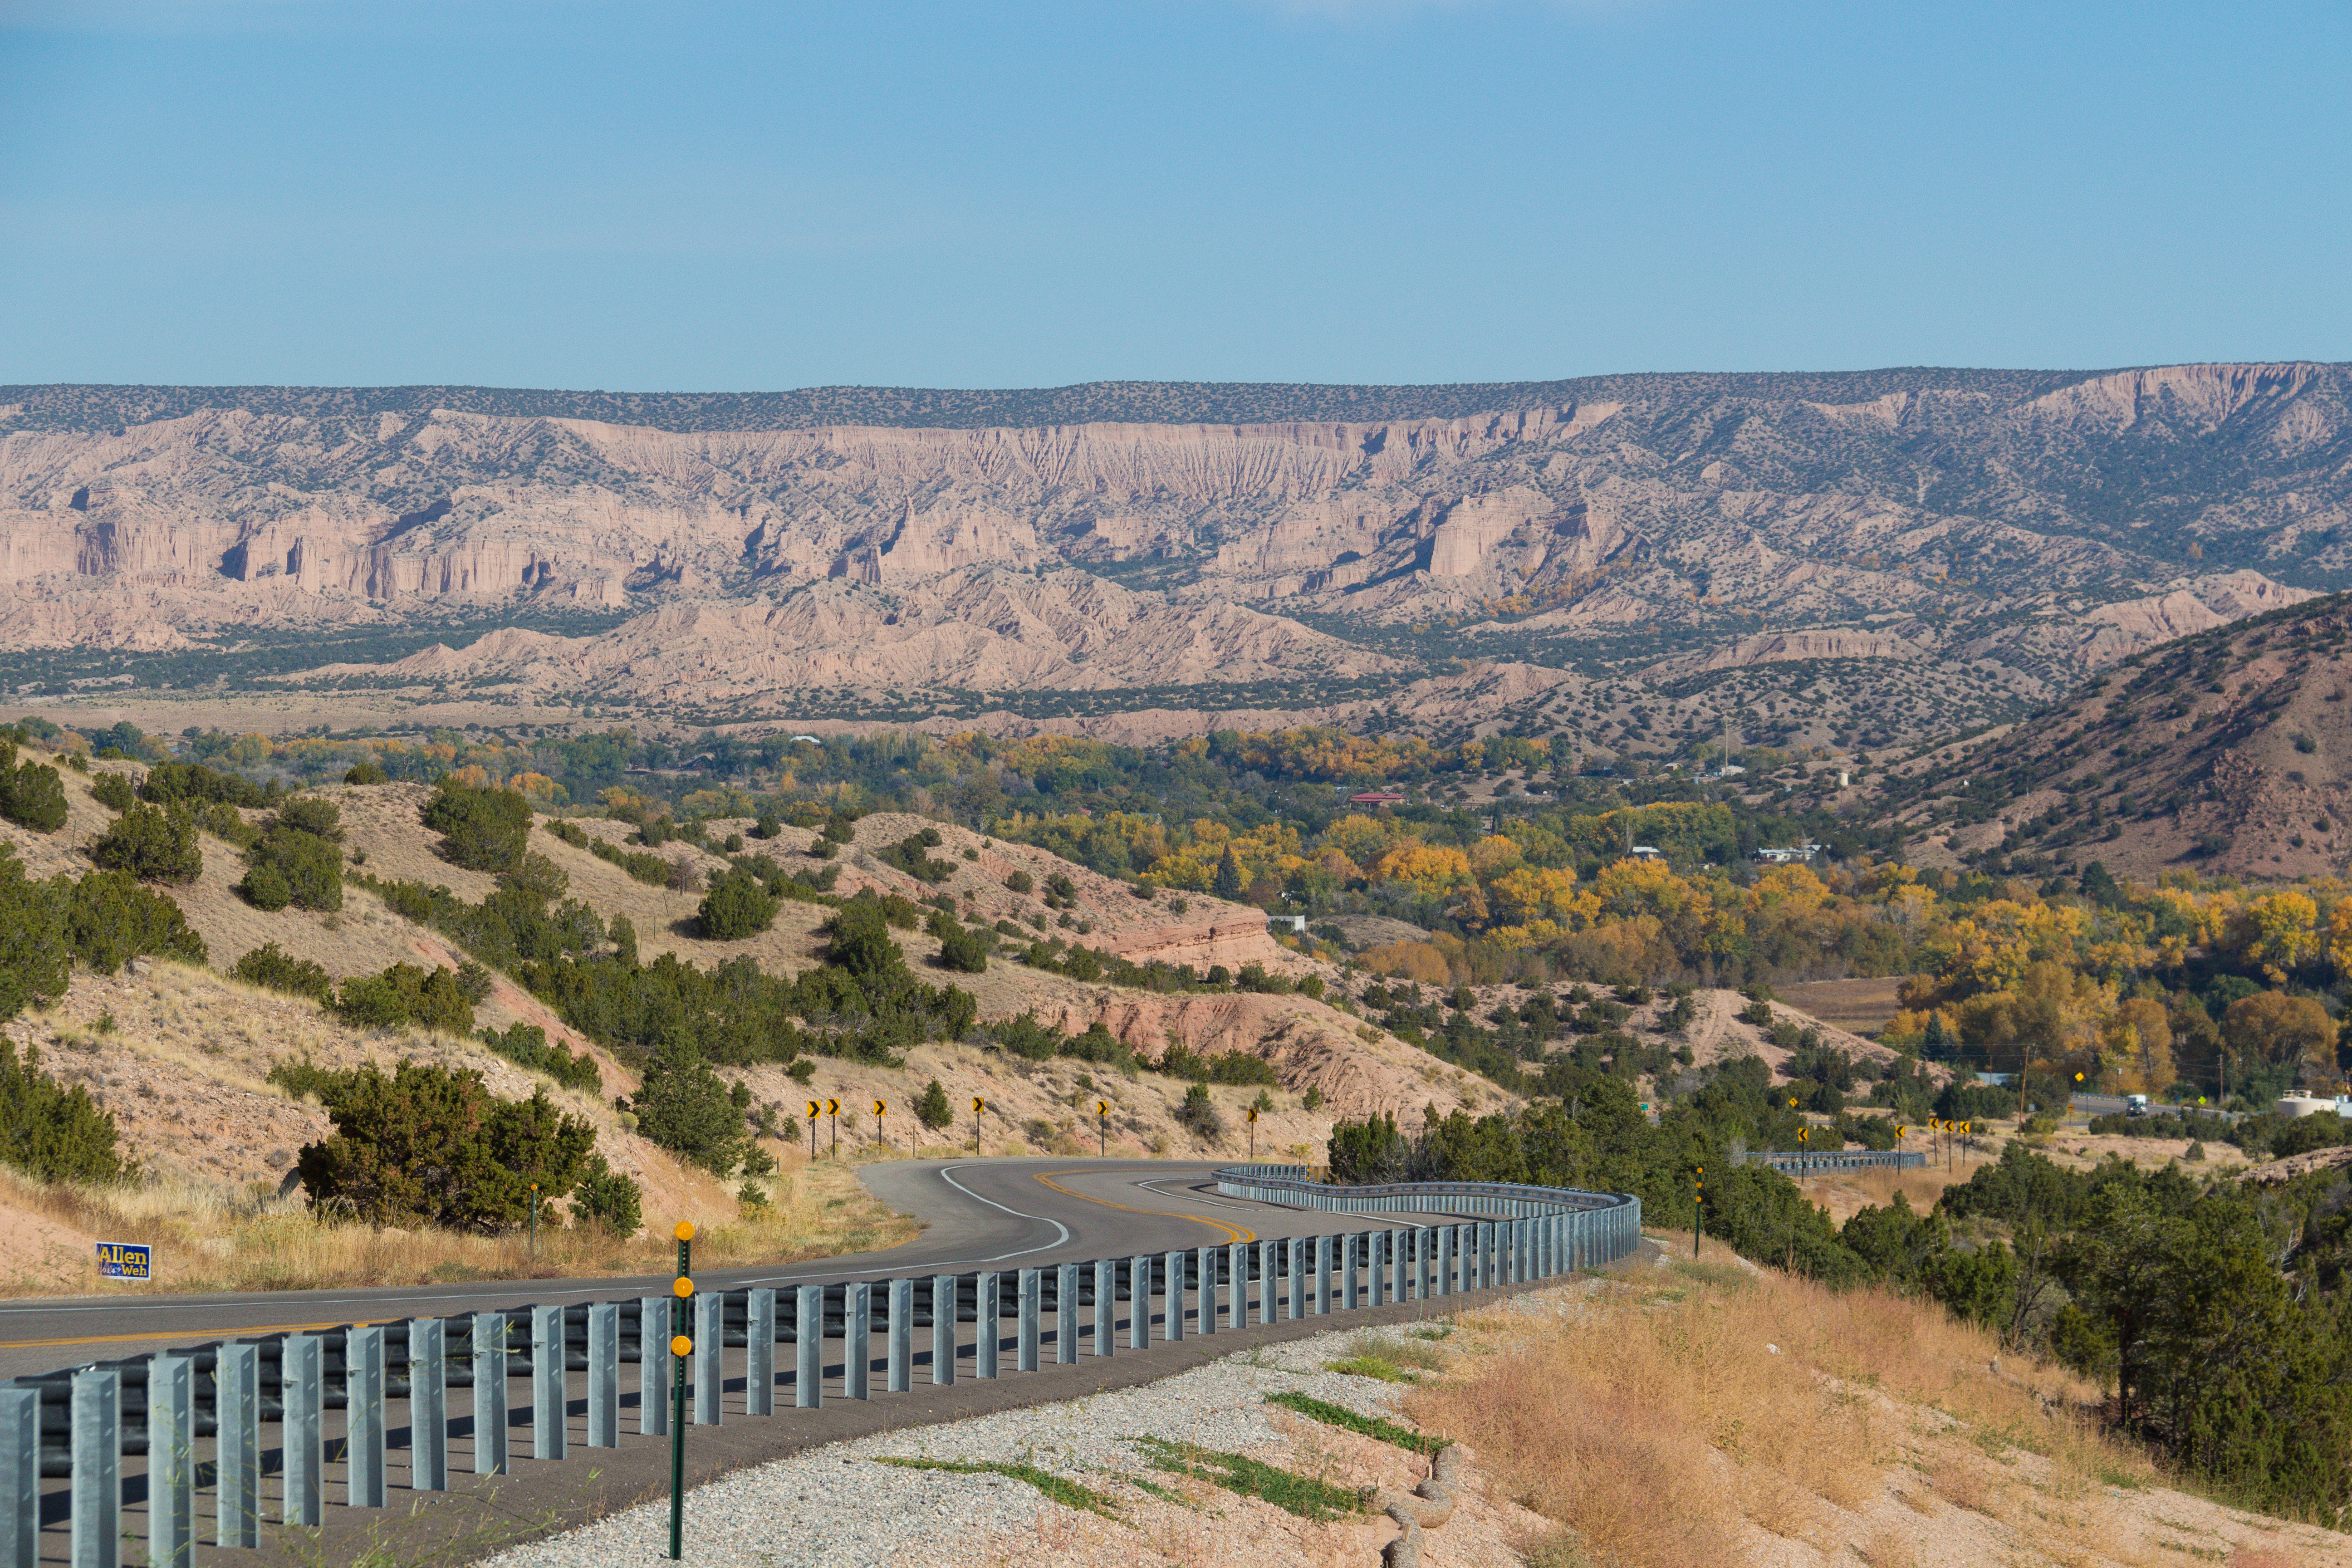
0,1159 -> 1426,1380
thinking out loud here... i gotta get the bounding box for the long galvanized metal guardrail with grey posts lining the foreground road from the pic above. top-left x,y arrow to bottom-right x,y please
0,1166 -> 1642,1568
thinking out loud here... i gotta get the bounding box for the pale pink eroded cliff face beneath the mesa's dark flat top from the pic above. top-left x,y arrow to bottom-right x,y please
0,364 -> 2352,715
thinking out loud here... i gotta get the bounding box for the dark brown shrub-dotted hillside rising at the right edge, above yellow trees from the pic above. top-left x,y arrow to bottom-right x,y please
1889,595 -> 2352,882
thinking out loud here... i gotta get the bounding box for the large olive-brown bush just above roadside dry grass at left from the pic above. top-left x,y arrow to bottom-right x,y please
294,1063 -> 595,1232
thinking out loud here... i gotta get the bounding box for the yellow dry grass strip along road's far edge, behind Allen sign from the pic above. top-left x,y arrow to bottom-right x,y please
0,1164 -> 915,1293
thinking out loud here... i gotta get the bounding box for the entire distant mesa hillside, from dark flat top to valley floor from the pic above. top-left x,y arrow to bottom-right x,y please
0,364 -> 2352,757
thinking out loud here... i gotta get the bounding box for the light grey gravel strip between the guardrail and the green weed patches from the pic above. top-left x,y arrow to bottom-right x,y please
489,1328 -> 1449,1568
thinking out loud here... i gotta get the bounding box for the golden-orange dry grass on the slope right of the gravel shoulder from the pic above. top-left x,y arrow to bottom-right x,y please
1409,1267 -> 2152,1568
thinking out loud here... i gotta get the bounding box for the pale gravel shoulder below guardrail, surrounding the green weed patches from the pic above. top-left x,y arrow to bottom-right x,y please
489,1328 -> 1543,1568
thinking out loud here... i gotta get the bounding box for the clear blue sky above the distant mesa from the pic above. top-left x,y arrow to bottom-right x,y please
0,0 -> 2352,390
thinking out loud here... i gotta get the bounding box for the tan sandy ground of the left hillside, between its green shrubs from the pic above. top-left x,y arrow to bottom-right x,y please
0,762 -> 1510,1288
